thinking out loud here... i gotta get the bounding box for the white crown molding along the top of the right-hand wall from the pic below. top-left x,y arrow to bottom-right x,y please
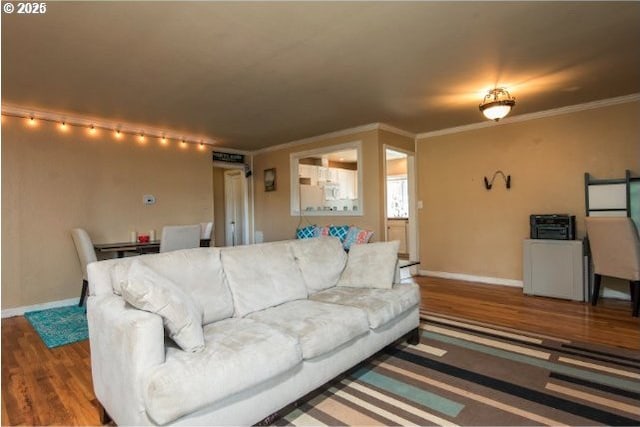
416,93 -> 640,141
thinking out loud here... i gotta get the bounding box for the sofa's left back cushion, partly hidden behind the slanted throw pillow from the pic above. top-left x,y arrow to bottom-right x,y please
107,248 -> 233,324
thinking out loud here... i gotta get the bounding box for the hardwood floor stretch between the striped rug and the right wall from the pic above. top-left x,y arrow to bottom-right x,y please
413,277 -> 640,350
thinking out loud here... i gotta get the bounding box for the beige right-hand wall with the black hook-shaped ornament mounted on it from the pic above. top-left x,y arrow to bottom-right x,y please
417,102 -> 640,280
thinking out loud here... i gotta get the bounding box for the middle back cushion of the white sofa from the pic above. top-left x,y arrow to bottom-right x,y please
222,242 -> 307,317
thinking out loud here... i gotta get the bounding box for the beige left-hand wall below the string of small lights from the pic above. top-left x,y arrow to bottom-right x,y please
2,117 -> 213,309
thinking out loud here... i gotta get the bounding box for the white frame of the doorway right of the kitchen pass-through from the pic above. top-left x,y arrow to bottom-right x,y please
382,144 -> 420,260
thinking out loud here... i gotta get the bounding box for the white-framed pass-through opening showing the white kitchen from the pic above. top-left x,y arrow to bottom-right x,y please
291,141 -> 363,216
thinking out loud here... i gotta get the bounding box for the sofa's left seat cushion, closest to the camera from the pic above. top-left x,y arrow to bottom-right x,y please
143,318 -> 302,424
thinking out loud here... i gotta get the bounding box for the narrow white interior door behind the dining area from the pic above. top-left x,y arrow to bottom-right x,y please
224,170 -> 247,246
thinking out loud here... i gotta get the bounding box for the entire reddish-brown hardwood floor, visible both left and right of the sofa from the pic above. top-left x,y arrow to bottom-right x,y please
2,277 -> 640,425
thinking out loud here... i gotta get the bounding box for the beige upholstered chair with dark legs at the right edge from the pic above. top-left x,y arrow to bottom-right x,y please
585,217 -> 640,317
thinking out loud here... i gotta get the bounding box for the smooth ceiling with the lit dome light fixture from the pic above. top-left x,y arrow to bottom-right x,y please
2,1 -> 640,150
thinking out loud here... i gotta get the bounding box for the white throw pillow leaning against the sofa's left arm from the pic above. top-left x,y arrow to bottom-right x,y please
122,260 -> 204,352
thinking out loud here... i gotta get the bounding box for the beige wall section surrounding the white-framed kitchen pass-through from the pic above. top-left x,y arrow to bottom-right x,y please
253,131 -> 383,242
